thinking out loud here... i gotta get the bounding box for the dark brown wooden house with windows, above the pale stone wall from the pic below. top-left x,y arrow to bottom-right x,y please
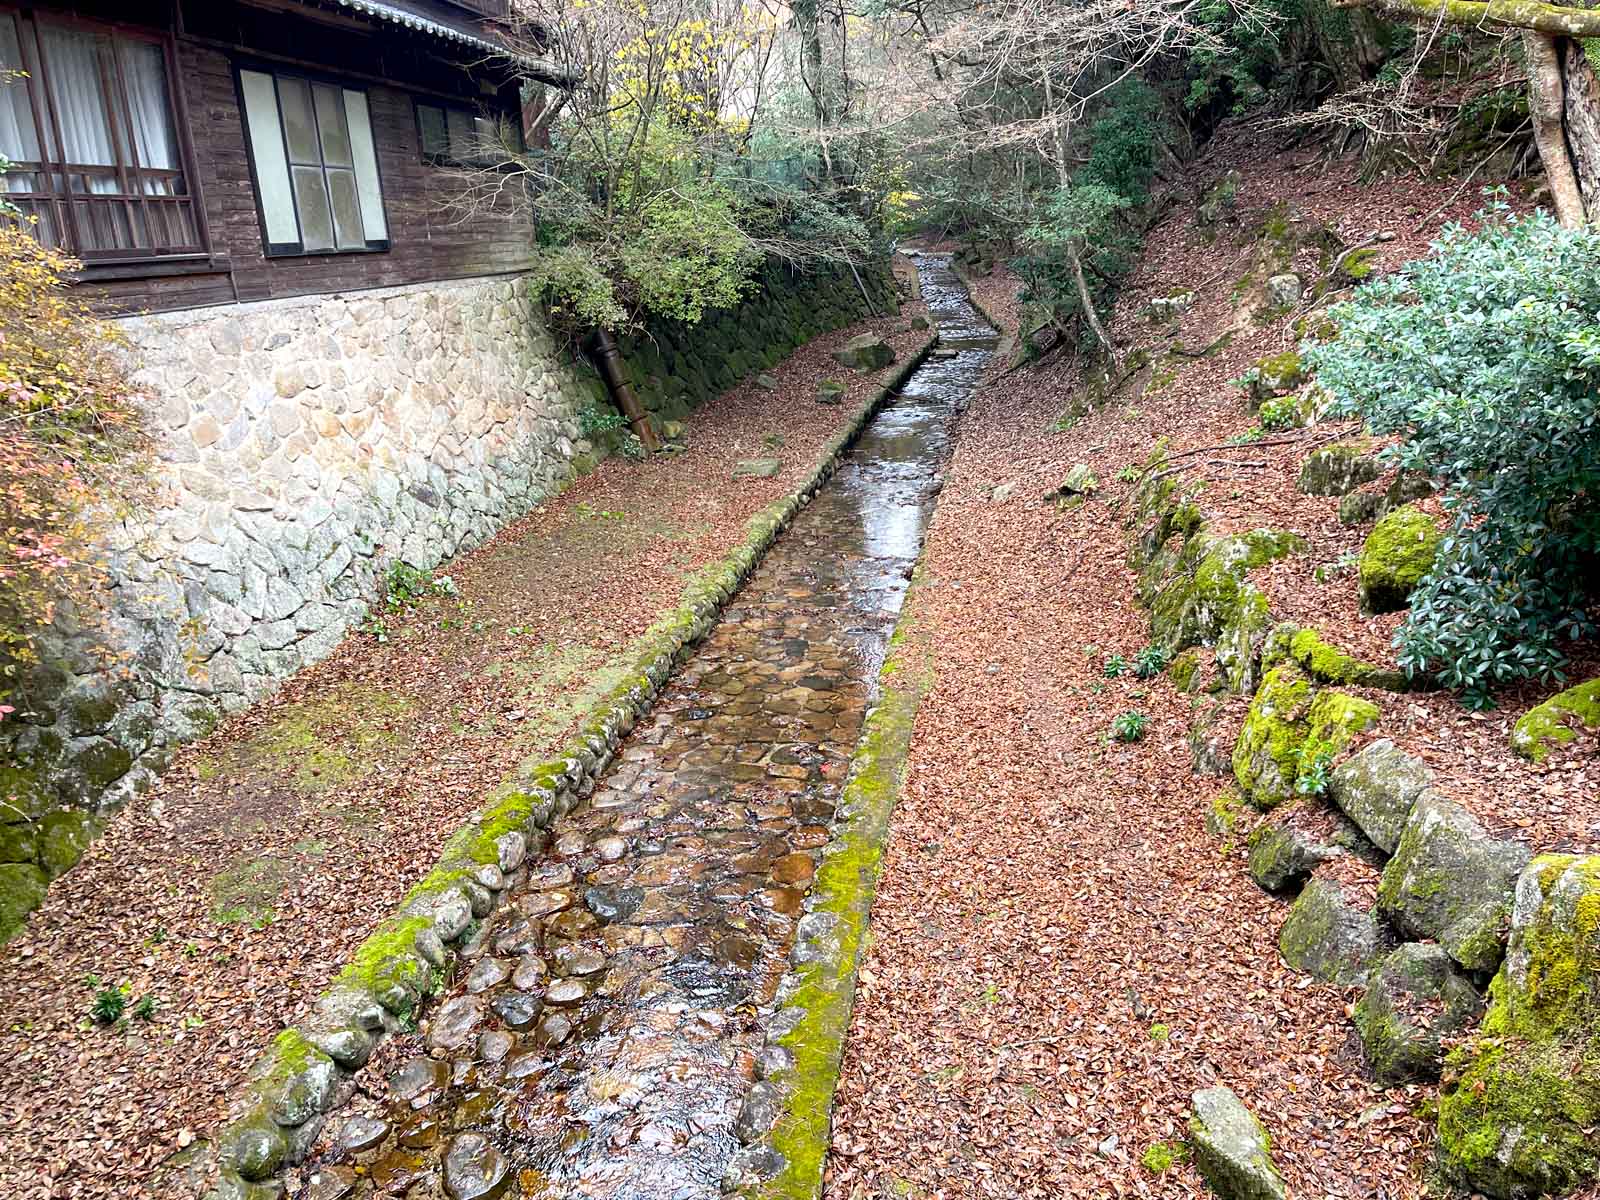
0,0 -> 550,312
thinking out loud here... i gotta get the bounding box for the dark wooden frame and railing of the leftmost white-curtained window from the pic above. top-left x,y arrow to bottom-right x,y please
0,3 -> 213,267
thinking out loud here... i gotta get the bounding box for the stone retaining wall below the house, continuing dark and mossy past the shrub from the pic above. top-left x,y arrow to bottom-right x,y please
0,262 -> 893,939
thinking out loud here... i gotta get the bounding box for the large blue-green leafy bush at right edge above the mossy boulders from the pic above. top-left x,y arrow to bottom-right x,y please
1302,200 -> 1600,706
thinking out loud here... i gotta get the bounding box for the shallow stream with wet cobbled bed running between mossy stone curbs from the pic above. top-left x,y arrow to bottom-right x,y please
299,256 -> 994,1200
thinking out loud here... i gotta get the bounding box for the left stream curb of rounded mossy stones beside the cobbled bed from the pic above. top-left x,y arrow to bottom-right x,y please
213,338 -> 936,1200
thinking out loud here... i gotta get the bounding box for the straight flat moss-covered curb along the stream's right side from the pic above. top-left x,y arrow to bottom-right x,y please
723,570 -> 933,1200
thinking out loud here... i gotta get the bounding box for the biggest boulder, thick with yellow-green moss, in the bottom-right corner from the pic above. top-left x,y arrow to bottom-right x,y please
1438,854 -> 1600,1200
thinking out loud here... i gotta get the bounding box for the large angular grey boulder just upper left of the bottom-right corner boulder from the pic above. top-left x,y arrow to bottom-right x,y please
1378,792 -> 1528,971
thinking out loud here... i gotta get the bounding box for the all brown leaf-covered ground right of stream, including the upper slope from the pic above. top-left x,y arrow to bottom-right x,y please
827,141 -> 1600,1200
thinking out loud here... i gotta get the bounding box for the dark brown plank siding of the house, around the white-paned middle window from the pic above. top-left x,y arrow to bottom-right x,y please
70,0 -> 533,312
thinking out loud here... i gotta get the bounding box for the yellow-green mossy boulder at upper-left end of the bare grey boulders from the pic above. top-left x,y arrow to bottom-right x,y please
1234,666 -> 1379,808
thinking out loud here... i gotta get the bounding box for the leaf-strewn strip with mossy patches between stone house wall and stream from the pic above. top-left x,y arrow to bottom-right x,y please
0,286 -> 926,1200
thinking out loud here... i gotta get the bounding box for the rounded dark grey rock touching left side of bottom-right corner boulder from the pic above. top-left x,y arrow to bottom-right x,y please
1354,942 -> 1483,1083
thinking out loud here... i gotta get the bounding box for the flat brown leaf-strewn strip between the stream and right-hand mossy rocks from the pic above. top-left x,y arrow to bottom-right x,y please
829,340 -> 1427,1200
